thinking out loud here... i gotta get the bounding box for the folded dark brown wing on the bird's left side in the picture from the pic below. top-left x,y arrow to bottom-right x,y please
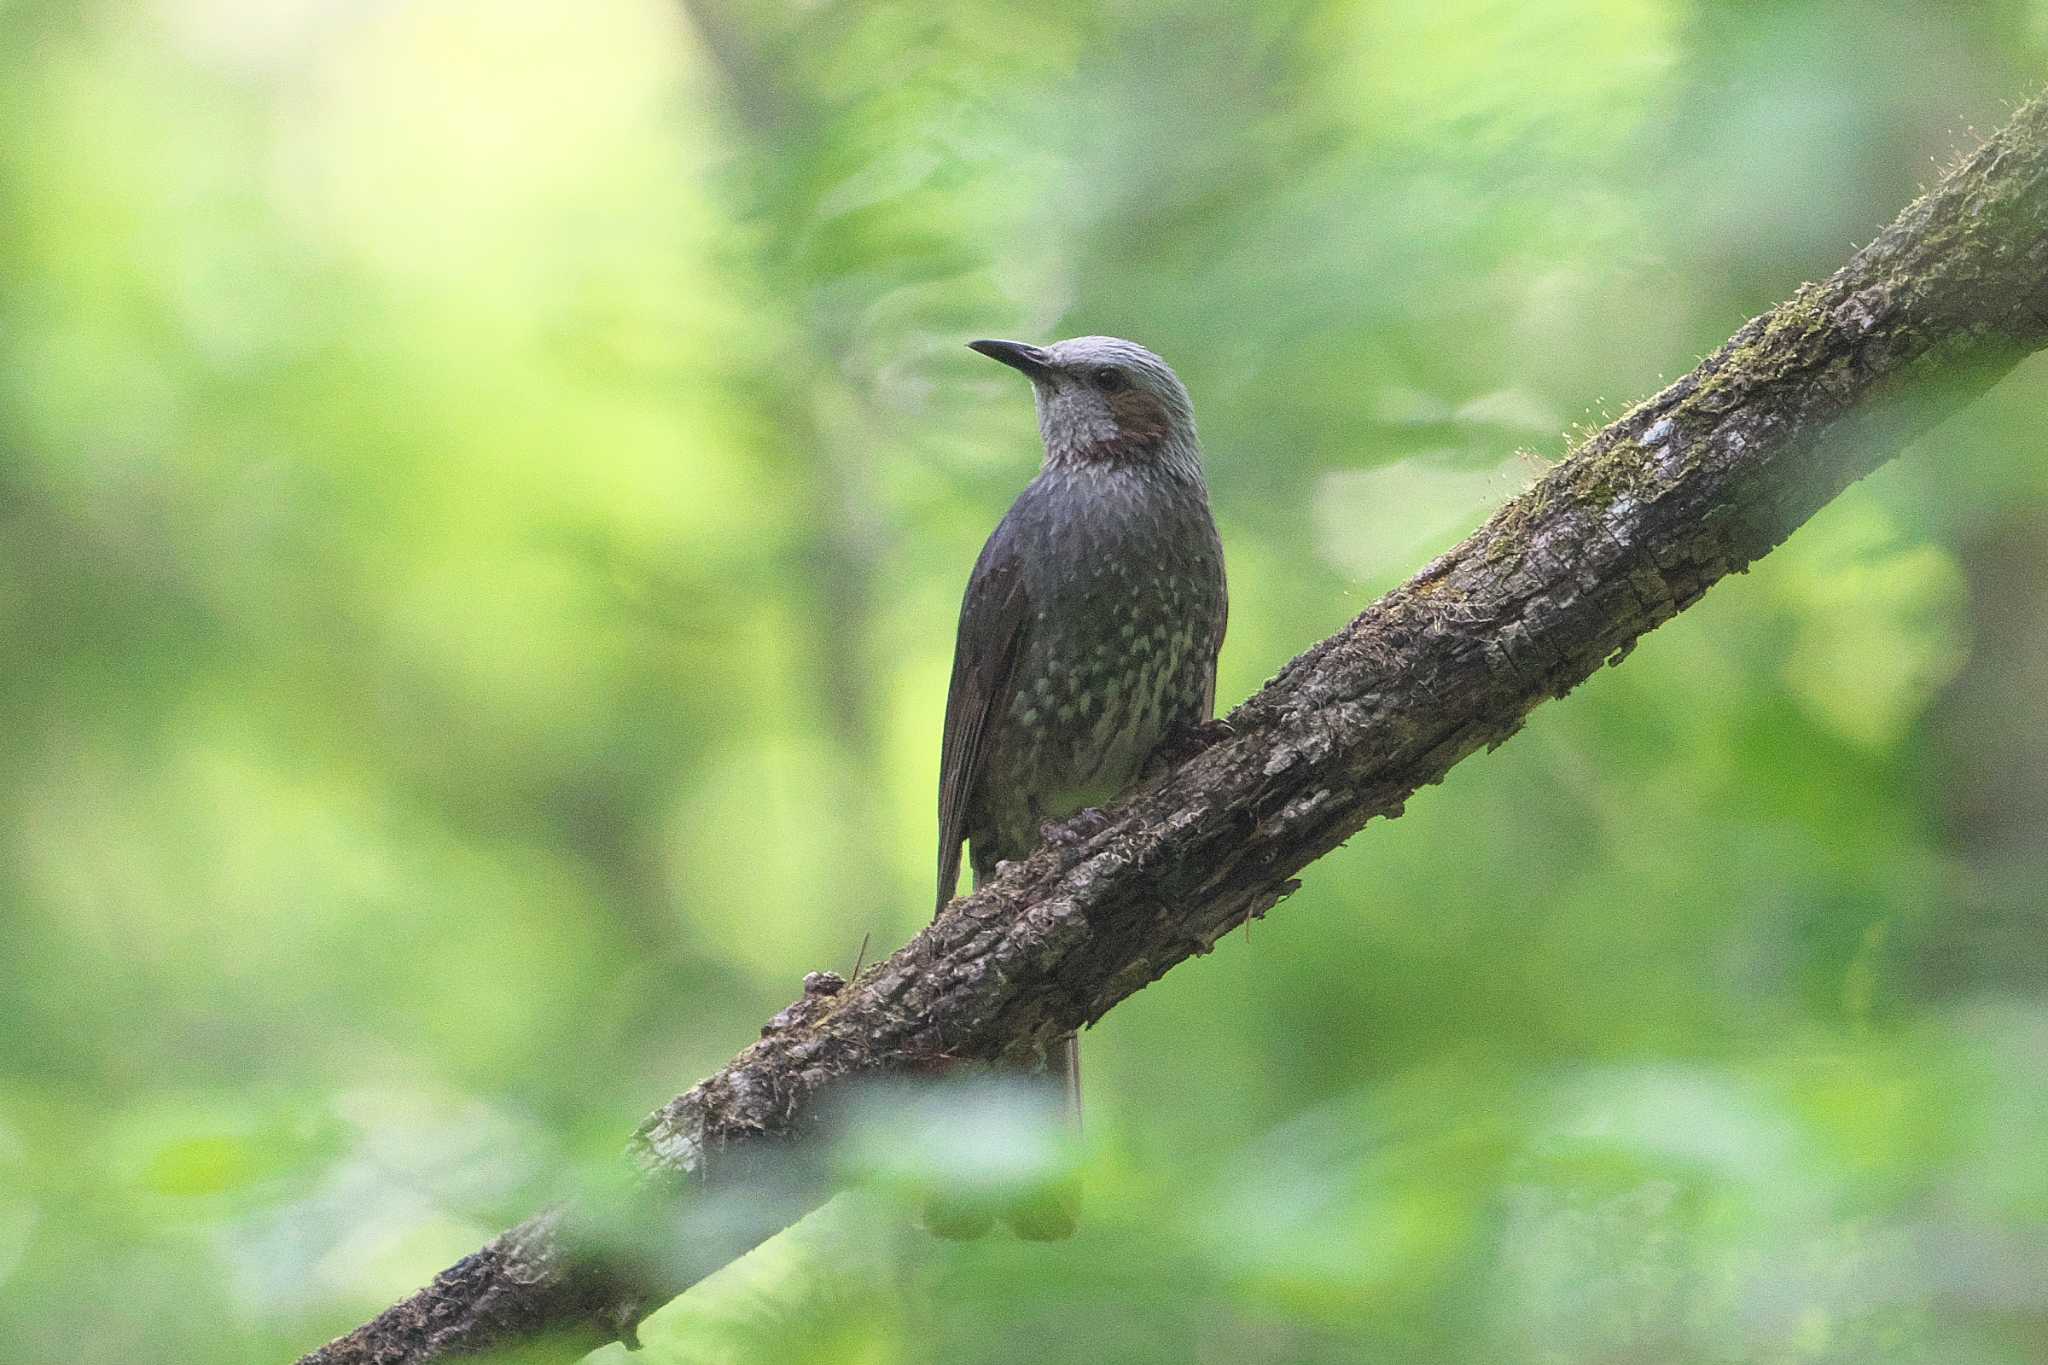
938,534 -> 1032,911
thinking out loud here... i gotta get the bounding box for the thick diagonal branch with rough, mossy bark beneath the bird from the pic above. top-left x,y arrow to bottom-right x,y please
305,100 -> 2048,1365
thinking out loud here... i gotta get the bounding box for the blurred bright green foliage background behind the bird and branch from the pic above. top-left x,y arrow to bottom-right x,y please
0,0 -> 2048,1365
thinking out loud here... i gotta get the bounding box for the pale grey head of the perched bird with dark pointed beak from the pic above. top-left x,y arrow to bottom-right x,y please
969,336 -> 1202,483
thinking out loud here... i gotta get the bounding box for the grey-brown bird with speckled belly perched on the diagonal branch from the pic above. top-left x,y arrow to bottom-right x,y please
924,336 -> 1229,1240
